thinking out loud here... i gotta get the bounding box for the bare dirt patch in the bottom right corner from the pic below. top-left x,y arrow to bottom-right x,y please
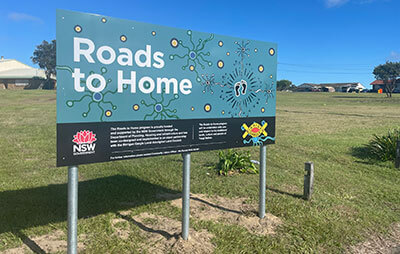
347,223 -> 400,254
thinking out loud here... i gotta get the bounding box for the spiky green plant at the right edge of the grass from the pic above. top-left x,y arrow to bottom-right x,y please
366,129 -> 400,161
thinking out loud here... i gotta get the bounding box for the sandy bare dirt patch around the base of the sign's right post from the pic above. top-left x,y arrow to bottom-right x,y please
171,194 -> 282,235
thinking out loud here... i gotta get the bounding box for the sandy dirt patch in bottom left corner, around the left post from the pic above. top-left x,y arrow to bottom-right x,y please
0,230 -> 86,254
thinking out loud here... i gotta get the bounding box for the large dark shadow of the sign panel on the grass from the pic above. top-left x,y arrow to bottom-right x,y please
0,175 -> 178,235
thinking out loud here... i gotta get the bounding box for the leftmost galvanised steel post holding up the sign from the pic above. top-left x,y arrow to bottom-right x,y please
67,166 -> 78,254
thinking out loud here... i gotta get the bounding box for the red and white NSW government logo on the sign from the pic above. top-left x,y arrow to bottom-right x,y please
72,130 -> 97,155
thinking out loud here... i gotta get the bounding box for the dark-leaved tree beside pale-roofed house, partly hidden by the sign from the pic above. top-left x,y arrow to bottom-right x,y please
31,40 -> 56,89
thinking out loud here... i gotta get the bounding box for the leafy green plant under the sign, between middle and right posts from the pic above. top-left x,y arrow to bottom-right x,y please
216,149 -> 258,176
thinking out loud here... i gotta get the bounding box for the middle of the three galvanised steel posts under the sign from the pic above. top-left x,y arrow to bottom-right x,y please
182,153 -> 190,240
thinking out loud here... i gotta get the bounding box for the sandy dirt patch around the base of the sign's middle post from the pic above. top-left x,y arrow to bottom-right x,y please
115,210 -> 214,254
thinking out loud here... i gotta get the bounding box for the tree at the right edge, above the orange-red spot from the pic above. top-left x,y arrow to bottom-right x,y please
373,62 -> 400,97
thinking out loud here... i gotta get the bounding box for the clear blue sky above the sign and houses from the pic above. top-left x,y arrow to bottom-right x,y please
0,0 -> 400,88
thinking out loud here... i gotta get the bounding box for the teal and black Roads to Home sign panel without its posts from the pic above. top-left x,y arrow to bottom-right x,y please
57,10 -> 277,166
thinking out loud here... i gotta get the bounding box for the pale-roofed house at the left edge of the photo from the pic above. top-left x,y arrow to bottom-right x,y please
0,56 -> 52,89
